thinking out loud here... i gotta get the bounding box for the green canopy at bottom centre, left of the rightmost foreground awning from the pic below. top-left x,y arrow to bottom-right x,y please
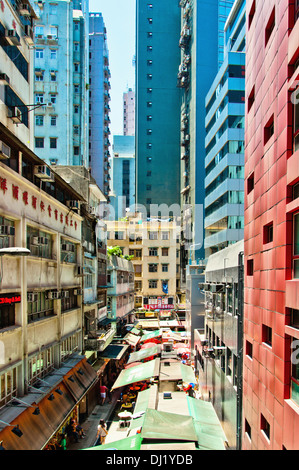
141,408 -> 197,442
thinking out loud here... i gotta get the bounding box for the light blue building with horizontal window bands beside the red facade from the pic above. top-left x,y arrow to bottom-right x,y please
204,0 -> 246,258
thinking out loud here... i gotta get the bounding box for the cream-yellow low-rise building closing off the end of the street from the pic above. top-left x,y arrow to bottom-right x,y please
107,215 -> 180,310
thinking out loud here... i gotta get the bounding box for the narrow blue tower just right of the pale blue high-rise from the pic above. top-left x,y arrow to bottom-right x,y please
89,13 -> 111,197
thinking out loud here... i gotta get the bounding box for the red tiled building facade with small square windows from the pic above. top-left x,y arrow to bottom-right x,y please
242,0 -> 299,450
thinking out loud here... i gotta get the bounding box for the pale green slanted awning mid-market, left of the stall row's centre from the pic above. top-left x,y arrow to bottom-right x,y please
111,359 -> 160,390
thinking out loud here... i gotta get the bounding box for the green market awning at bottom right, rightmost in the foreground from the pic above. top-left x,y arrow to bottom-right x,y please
187,396 -> 227,449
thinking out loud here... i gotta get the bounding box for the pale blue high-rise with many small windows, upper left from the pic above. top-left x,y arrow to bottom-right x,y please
34,0 -> 88,167
